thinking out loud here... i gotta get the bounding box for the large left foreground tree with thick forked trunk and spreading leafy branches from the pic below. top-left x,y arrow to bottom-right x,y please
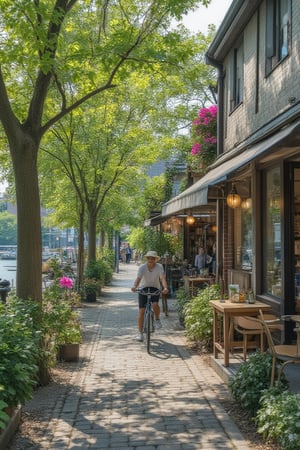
0,0 -> 209,299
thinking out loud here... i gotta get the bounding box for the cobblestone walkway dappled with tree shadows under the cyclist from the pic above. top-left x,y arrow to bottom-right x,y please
8,263 -> 250,450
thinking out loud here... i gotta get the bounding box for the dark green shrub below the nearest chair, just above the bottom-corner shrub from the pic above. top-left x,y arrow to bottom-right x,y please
228,351 -> 287,416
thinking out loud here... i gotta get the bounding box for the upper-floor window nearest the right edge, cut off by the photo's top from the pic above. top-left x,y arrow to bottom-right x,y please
266,0 -> 291,74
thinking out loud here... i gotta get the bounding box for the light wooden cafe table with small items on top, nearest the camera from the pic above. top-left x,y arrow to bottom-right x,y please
209,300 -> 271,367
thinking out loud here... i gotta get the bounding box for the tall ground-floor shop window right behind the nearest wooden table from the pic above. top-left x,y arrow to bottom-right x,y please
261,167 -> 282,297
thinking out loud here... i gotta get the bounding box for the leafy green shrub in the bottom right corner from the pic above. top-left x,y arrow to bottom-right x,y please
256,388 -> 300,450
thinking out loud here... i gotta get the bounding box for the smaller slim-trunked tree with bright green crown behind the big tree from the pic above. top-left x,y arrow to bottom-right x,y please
42,85 -> 160,261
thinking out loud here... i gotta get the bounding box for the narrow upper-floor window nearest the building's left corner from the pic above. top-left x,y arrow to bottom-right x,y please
230,40 -> 244,110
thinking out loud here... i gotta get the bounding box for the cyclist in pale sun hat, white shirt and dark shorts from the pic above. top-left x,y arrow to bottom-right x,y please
131,251 -> 168,341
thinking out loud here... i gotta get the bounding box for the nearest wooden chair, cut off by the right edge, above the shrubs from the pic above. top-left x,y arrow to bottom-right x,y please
247,311 -> 300,387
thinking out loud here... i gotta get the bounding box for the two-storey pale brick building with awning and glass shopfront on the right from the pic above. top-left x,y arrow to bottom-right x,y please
162,0 -> 300,340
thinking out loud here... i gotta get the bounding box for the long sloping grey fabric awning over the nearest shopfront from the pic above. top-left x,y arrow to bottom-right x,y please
161,121 -> 300,217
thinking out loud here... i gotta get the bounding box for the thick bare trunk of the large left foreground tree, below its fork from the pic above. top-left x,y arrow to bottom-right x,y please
10,134 -> 42,301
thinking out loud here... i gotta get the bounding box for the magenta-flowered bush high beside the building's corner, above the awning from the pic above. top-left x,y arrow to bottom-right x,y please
190,105 -> 218,170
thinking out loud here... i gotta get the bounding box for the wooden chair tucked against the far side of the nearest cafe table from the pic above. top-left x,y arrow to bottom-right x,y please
233,314 -> 283,360
